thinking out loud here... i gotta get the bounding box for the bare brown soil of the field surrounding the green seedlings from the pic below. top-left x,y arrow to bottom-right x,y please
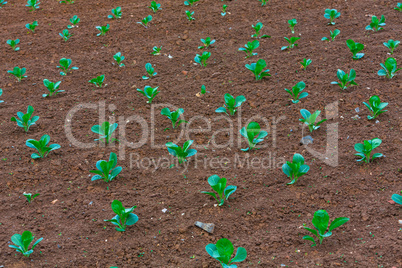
0,0 -> 402,267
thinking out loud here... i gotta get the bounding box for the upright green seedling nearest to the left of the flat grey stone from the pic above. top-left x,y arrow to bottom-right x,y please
105,200 -> 138,232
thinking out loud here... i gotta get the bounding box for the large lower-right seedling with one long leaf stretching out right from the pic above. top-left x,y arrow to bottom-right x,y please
303,210 -> 349,247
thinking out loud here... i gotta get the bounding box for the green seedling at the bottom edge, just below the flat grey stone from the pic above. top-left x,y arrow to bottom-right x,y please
205,238 -> 247,268
